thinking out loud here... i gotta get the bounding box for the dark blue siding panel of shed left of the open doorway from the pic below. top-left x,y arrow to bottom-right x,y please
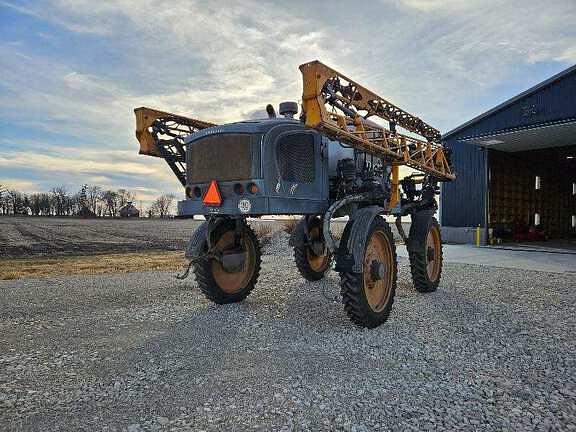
441,140 -> 486,227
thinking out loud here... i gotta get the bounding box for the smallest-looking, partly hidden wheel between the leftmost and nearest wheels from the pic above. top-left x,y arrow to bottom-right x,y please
294,218 -> 332,281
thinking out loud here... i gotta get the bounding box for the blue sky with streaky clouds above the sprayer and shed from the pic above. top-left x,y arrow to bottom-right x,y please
0,0 -> 576,201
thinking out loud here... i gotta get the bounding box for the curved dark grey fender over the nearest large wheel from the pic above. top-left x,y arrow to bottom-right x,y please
335,206 -> 384,273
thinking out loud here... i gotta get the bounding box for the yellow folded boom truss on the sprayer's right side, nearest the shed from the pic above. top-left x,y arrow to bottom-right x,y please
300,61 -> 456,181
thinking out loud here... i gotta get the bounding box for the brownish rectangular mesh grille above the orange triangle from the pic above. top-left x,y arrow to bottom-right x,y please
187,134 -> 252,183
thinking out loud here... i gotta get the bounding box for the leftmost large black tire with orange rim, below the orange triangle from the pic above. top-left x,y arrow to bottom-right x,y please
194,221 -> 262,304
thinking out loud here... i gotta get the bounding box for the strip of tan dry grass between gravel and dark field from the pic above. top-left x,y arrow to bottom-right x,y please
0,251 -> 188,280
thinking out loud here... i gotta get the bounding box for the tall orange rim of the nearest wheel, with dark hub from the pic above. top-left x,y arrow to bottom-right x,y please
364,231 -> 394,312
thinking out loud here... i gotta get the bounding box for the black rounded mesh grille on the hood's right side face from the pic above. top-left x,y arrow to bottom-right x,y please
276,134 -> 315,183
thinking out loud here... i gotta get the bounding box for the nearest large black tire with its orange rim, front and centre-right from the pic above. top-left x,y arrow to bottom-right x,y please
340,216 -> 397,328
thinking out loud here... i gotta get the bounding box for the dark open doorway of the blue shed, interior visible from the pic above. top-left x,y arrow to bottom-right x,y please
488,145 -> 576,249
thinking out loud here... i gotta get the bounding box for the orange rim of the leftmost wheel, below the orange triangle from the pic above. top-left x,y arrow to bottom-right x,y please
212,230 -> 256,294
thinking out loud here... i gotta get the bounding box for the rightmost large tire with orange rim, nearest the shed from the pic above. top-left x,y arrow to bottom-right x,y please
408,213 -> 442,293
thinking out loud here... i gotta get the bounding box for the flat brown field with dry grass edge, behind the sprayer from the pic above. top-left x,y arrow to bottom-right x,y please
0,217 -> 344,280
